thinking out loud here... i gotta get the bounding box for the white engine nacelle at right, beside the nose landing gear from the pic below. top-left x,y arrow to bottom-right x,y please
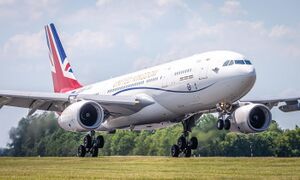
230,104 -> 272,133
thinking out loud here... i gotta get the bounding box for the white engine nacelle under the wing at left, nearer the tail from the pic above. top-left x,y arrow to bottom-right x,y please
58,100 -> 104,132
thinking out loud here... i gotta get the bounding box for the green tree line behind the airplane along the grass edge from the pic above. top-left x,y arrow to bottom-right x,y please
0,113 -> 300,157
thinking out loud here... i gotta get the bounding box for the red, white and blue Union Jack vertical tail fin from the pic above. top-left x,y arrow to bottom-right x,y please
45,23 -> 82,93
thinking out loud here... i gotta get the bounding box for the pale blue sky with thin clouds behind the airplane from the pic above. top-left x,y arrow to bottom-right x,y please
0,0 -> 300,147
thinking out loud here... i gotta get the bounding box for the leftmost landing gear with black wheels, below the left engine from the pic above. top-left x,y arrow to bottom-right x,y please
77,131 -> 104,157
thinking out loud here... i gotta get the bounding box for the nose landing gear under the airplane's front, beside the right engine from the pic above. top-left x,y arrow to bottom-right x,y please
217,103 -> 232,130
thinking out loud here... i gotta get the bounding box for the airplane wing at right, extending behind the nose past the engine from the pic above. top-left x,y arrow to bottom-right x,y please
240,96 -> 300,112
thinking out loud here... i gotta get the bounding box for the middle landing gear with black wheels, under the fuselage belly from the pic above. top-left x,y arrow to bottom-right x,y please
171,116 -> 198,157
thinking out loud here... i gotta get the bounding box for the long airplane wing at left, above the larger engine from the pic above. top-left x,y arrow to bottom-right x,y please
0,91 -> 154,117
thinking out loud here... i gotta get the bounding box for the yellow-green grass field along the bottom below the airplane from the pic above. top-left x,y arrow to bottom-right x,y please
0,157 -> 300,179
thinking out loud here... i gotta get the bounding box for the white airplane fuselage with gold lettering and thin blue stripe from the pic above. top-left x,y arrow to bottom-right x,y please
72,51 -> 256,131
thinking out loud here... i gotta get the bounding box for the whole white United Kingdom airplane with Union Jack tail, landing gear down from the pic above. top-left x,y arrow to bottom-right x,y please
0,23 -> 300,157
